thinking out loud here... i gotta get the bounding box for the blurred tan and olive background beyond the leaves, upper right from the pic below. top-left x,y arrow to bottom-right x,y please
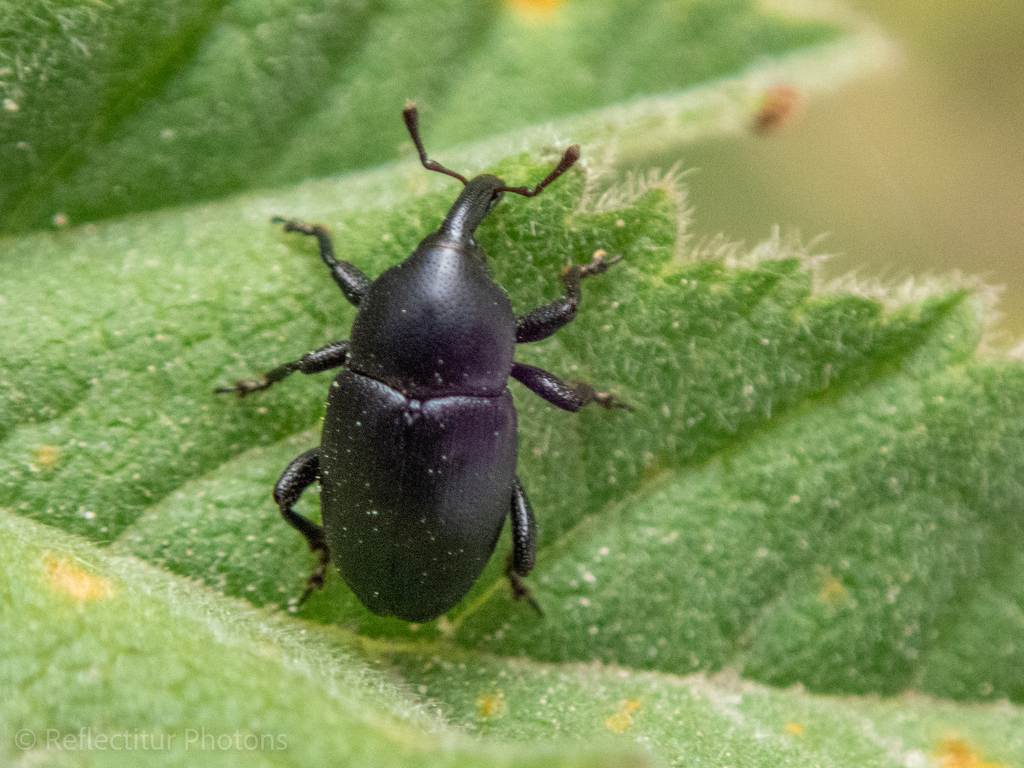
675,0 -> 1024,335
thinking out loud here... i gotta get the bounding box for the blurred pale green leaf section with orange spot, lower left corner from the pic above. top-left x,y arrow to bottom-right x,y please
0,513 -> 624,768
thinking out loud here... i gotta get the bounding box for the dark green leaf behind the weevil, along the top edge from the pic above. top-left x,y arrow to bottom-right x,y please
0,0 -> 856,232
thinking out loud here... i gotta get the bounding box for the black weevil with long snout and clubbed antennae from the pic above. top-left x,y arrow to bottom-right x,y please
216,102 -> 625,622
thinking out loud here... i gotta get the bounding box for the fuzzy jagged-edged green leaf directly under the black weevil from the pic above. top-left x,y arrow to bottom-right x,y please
0,150 -> 1024,764
